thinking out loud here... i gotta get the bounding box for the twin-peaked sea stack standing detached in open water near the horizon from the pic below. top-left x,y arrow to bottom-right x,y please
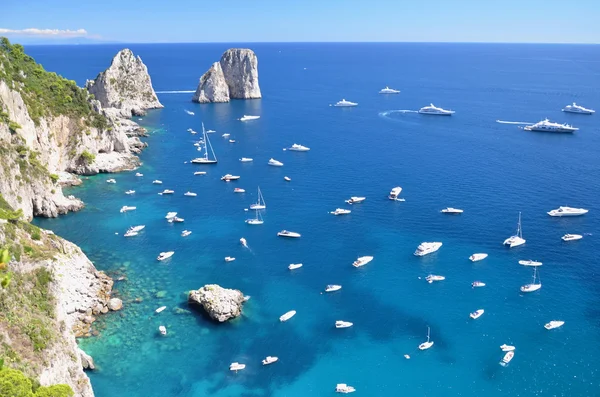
192,48 -> 261,103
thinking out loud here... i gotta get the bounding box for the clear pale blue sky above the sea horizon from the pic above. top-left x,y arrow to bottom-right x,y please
0,0 -> 600,44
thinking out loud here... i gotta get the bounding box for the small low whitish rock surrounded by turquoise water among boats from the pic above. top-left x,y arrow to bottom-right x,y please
188,284 -> 244,323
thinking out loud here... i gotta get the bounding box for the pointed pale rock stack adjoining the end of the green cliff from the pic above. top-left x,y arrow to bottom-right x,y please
86,48 -> 163,117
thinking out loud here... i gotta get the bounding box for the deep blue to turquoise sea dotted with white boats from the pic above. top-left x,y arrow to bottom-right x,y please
31,43 -> 600,397
